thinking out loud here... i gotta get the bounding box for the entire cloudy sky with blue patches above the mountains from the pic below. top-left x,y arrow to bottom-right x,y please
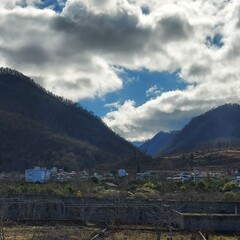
0,0 -> 240,141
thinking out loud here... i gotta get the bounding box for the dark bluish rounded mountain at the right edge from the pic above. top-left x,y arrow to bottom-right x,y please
164,104 -> 240,153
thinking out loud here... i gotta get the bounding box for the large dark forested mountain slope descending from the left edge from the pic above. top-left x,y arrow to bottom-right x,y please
0,68 -> 141,171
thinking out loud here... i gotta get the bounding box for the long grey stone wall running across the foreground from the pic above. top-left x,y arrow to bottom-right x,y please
0,196 -> 240,231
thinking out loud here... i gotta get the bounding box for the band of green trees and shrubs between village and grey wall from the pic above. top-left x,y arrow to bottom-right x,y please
0,175 -> 240,201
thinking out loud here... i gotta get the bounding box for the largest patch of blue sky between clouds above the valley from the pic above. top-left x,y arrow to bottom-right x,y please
80,69 -> 187,117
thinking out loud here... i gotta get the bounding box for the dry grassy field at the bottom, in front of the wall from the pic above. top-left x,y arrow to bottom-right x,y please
0,225 -> 240,240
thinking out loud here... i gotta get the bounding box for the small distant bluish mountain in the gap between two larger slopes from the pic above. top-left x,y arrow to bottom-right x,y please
139,131 -> 178,157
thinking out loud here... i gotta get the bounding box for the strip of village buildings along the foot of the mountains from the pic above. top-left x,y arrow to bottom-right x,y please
0,166 -> 240,185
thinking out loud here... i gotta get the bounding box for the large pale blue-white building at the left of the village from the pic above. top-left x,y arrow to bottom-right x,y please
25,167 -> 51,183
